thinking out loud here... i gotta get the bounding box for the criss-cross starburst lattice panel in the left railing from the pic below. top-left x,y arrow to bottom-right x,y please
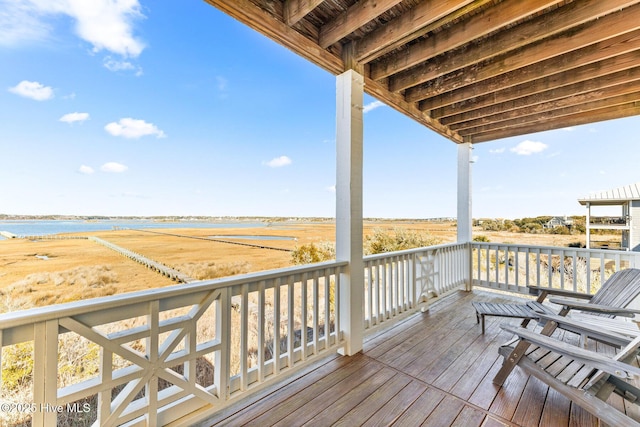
52,290 -> 227,426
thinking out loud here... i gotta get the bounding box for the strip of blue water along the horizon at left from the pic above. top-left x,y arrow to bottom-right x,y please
0,220 -> 267,239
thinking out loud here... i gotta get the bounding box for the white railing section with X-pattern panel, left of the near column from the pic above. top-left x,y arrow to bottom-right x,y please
0,262 -> 346,426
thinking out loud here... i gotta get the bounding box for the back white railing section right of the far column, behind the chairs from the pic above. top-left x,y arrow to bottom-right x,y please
471,242 -> 640,294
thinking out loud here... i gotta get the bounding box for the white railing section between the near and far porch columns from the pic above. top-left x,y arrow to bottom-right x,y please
364,244 -> 469,332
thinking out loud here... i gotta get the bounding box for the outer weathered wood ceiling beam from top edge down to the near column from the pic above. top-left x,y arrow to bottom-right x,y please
205,0 -> 344,75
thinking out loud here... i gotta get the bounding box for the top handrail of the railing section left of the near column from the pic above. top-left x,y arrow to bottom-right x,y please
0,261 -> 348,330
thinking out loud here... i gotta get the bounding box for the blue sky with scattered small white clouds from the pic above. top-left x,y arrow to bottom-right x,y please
0,0 -> 640,218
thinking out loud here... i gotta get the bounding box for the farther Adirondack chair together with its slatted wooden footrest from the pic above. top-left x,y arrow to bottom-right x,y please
472,268 -> 640,334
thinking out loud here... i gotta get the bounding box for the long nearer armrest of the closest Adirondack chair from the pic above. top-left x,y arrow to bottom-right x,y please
500,325 -> 640,379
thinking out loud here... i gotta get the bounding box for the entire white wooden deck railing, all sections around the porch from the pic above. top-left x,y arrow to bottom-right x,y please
10,242 -> 640,426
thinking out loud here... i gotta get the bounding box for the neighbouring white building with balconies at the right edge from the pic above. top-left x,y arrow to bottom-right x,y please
578,182 -> 640,252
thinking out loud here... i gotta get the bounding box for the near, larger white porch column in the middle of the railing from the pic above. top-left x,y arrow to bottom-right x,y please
336,70 -> 364,356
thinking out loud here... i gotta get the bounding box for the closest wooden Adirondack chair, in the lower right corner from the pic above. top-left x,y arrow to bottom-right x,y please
500,325 -> 640,427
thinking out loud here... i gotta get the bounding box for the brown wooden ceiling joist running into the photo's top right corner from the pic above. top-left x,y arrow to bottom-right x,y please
389,0 -> 638,94
